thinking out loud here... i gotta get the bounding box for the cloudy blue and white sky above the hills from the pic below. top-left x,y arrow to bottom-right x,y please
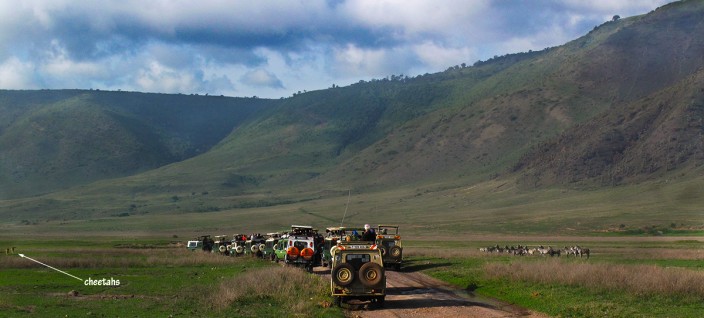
0,0 -> 672,98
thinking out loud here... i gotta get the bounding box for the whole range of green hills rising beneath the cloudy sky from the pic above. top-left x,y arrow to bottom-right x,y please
0,1 -> 704,234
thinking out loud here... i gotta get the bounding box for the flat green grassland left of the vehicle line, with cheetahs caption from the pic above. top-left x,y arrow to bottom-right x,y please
0,237 -> 343,317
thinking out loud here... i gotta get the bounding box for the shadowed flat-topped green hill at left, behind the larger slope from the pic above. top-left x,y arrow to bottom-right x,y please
0,90 -> 270,198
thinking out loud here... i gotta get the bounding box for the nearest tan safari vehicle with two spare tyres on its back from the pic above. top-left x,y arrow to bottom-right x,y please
330,242 -> 386,306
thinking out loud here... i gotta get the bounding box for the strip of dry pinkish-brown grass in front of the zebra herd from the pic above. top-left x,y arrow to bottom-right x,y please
484,260 -> 704,299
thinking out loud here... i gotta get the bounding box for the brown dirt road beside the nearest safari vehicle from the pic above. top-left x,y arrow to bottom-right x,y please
316,267 -> 547,318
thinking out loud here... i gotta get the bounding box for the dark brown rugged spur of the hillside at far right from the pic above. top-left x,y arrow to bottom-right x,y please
515,67 -> 704,187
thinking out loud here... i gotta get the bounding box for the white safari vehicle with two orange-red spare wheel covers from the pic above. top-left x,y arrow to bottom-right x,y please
279,225 -> 318,272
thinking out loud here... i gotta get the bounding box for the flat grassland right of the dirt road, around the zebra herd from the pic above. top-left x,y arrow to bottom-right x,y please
405,236 -> 704,317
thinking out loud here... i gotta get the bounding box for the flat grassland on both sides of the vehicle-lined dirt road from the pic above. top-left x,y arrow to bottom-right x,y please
0,235 -> 704,317
